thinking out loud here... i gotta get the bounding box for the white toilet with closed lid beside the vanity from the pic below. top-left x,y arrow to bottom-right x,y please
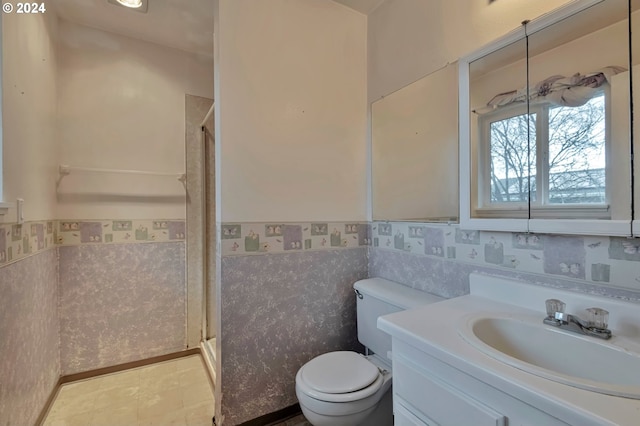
296,278 -> 443,426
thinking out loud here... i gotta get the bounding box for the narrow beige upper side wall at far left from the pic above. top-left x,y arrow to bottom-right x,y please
0,10 -> 58,222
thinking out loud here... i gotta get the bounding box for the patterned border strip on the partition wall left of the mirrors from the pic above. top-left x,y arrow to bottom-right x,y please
219,221 -> 372,256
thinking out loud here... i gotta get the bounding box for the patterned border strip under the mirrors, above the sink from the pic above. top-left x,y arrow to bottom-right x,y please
371,222 -> 640,291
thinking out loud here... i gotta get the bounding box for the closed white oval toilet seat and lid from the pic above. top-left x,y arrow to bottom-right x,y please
296,351 -> 384,402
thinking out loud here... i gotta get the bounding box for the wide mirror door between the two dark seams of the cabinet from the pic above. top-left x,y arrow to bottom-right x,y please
528,0 -> 631,220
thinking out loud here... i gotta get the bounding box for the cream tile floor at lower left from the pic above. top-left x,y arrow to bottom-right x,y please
43,355 -> 214,426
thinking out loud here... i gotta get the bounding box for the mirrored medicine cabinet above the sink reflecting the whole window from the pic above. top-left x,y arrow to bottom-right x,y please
461,0 -> 631,235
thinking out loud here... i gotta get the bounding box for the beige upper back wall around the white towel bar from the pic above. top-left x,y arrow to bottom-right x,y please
58,21 -> 213,219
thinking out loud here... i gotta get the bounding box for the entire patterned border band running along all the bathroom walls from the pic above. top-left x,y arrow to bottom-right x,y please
5,219 -> 640,291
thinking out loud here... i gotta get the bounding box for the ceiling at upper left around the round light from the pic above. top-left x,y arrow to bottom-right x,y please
54,0 -> 213,56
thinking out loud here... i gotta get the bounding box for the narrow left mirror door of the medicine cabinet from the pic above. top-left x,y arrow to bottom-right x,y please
466,39 -> 529,226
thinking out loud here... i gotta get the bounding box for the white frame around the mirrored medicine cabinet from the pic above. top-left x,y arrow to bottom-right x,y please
458,0 -> 633,236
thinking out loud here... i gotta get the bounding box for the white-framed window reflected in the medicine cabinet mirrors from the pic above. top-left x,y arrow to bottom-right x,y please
477,91 -> 609,218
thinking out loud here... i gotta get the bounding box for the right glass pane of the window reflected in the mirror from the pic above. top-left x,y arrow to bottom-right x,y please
548,95 -> 606,204
